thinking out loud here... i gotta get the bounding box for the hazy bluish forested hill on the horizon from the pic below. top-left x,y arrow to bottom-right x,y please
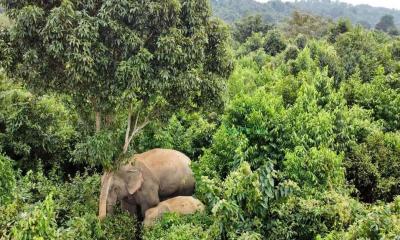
211,0 -> 400,27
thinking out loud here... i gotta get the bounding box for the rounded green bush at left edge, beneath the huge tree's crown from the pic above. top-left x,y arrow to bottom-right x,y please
0,72 -> 77,171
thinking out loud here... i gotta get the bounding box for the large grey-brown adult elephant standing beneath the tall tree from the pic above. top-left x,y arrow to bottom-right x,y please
99,148 -> 195,220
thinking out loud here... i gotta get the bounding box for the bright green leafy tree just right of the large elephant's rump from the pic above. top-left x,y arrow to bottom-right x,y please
200,90 -> 284,177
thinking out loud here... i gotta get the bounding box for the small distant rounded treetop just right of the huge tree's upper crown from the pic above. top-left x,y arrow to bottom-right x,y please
233,15 -> 272,43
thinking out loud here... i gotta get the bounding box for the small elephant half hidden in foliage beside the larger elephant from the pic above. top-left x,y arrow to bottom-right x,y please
143,196 -> 204,226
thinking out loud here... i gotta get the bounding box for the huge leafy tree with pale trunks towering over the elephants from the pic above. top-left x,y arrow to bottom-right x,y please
0,0 -> 232,219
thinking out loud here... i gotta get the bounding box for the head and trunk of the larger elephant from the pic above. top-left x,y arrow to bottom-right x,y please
99,164 -> 143,220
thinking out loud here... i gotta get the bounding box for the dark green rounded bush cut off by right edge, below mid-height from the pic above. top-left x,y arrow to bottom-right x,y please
346,132 -> 400,202
